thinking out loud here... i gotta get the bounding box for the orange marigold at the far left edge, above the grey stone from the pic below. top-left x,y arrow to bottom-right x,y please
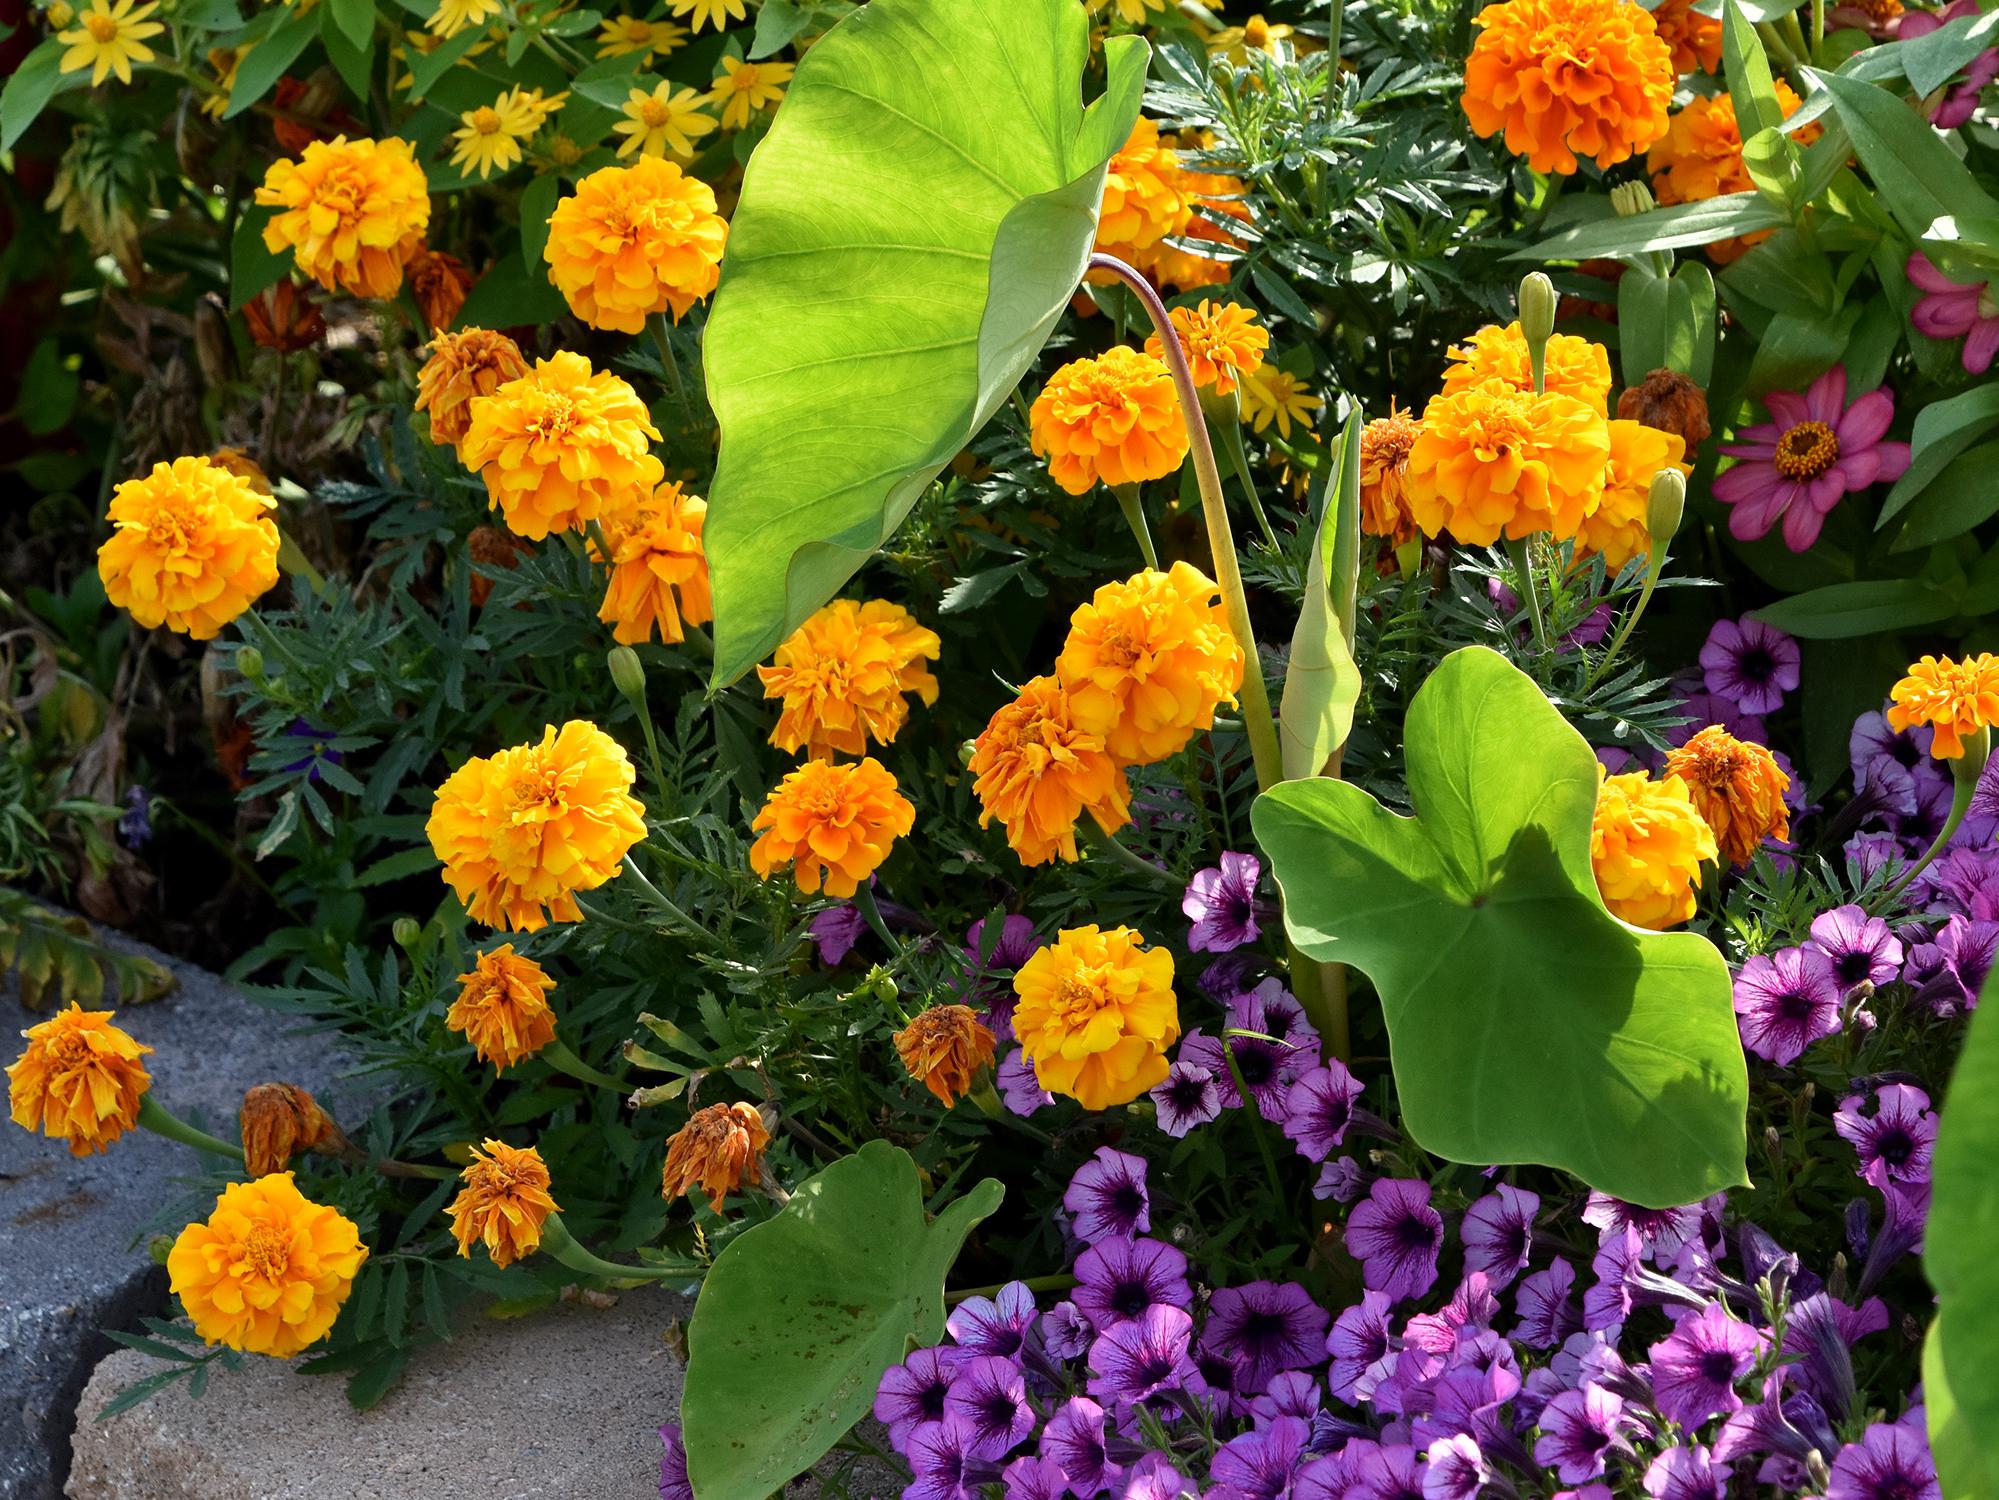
6,1000 -> 152,1156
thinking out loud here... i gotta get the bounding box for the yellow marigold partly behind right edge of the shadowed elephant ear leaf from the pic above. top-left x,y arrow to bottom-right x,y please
1589,768 -> 1715,932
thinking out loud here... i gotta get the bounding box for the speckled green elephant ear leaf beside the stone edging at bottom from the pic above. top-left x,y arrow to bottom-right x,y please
680,1140 -> 1003,1500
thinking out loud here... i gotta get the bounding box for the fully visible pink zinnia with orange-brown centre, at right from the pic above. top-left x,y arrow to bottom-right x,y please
1715,364 -> 1909,552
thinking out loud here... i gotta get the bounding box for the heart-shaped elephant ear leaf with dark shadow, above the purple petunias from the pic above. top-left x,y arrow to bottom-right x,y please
1253,646 -> 1749,1208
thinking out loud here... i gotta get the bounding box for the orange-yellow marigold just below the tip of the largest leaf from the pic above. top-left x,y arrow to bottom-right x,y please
756,598 -> 942,758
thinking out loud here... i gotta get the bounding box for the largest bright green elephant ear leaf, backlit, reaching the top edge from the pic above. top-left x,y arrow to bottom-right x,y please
706,0 -> 1147,684
